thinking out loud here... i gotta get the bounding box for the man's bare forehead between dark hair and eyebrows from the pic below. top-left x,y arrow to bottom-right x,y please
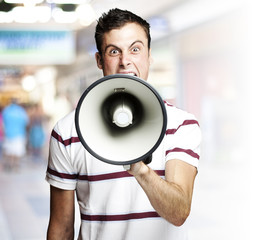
102,23 -> 148,49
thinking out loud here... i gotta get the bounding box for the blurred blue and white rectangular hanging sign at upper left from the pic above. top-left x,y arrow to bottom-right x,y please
0,30 -> 75,65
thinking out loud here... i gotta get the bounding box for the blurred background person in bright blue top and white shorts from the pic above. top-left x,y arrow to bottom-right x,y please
2,98 -> 29,170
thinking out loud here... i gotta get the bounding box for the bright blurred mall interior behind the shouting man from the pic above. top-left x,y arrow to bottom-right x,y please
0,0 -> 253,240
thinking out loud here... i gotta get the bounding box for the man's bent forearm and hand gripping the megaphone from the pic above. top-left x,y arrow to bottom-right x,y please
129,159 -> 197,226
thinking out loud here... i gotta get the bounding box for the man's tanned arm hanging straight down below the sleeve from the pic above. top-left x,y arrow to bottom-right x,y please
47,186 -> 75,240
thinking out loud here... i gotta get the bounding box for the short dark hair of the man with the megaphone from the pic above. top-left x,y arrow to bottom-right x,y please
95,8 -> 151,54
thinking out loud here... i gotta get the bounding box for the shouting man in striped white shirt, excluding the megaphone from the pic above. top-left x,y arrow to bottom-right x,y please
46,9 -> 201,240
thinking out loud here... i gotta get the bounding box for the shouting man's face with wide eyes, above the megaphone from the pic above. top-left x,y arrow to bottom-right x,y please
96,23 -> 151,80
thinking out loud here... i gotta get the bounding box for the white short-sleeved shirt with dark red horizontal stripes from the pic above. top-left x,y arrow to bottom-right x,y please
46,103 -> 201,240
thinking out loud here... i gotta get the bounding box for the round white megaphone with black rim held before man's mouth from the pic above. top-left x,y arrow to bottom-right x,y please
75,74 -> 167,165
